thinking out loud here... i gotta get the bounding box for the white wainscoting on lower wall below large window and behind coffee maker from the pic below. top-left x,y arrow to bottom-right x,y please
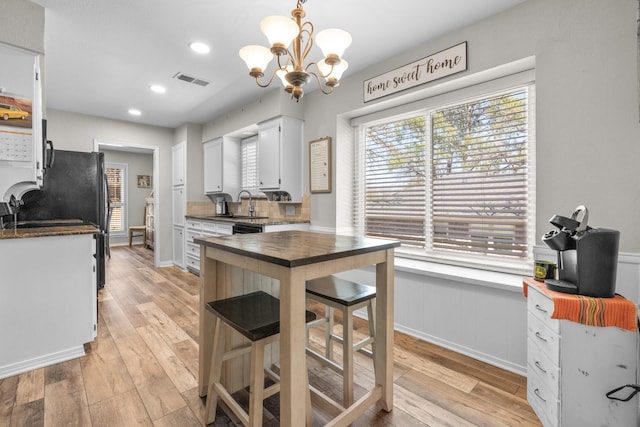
315,229 -> 640,375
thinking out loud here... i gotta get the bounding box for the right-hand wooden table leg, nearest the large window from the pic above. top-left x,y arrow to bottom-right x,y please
374,249 -> 394,412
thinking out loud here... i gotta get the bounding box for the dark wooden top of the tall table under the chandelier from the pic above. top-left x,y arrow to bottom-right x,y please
194,231 -> 400,268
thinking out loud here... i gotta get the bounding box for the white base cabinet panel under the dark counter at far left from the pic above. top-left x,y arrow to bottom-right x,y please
0,234 -> 96,382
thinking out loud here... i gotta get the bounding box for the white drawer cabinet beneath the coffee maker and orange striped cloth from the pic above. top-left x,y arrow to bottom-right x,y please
527,284 -> 640,427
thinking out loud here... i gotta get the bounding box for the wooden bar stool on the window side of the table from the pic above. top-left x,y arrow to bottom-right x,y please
307,276 -> 376,408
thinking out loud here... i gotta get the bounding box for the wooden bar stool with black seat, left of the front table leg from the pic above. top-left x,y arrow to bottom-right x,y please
205,291 -> 316,427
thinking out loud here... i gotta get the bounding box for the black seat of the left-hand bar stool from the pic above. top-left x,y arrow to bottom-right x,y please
206,291 -> 316,341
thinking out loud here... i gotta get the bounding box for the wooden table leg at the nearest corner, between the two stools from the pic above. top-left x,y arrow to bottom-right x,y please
280,269 -> 308,427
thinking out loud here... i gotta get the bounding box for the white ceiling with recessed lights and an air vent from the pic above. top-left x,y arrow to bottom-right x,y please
31,0 -> 524,128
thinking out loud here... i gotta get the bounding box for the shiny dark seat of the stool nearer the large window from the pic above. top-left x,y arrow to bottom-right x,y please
306,276 -> 376,307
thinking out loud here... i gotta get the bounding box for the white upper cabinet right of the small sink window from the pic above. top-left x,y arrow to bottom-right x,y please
258,116 -> 303,202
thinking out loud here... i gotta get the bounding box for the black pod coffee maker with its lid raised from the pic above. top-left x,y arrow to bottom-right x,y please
542,206 -> 620,298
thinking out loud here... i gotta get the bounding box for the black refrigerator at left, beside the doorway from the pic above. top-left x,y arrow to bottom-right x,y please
18,150 -> 109,289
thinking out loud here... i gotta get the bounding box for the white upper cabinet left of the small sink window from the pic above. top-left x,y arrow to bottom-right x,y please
204,137 -> 242,197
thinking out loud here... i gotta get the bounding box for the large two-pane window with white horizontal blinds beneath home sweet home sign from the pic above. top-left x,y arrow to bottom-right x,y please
354,86 -> 534,271
